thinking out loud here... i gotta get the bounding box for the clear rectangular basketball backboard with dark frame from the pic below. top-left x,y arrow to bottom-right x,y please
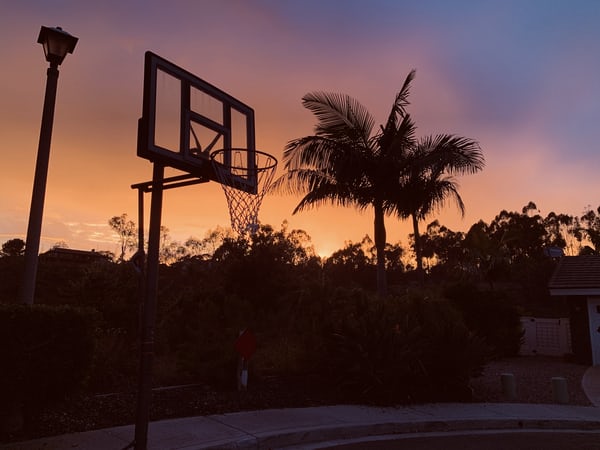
137,52 -> 256,192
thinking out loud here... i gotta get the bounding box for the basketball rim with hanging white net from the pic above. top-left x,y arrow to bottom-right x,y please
210,148 -> 277,235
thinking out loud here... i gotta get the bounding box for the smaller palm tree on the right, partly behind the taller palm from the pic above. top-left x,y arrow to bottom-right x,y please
395,134 -> 484,280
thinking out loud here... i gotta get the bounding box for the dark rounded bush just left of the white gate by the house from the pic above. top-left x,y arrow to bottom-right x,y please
445,284 -> 524,358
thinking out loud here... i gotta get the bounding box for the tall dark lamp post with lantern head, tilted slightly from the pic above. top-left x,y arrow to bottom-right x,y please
21,27 -> 77,305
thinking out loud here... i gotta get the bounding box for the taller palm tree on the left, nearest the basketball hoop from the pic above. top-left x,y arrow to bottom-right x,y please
273,71 -> 414,296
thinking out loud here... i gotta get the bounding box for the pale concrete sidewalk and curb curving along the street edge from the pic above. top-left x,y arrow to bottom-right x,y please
0,368 -> 600,450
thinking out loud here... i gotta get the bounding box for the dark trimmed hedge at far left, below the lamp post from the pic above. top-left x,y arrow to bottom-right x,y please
0,304 -> 95,409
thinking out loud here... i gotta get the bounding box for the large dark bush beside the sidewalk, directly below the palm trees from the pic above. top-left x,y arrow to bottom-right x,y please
323,297 -> 487,404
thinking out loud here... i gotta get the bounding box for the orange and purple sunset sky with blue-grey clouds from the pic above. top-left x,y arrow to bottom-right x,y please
0,0 -> 600,255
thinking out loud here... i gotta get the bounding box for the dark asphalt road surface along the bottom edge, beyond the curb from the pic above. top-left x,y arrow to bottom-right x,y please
318,430 -> 600,450
